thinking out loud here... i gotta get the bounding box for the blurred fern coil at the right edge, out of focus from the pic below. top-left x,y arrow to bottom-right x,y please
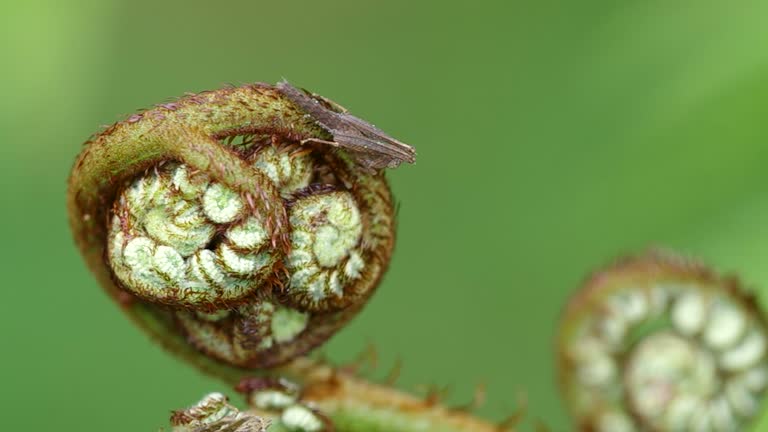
558,254 -> 768,432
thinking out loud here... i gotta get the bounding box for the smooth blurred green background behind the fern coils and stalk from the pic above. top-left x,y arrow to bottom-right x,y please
7,0 -> 768,432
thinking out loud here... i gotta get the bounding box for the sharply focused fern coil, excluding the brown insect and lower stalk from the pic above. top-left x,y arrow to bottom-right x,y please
69,85 -> 402,368
